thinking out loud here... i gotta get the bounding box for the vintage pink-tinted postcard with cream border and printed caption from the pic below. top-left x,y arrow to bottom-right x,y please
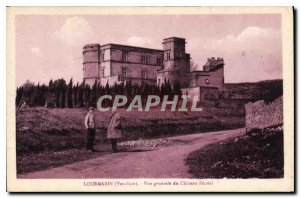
7,7 -> 294,192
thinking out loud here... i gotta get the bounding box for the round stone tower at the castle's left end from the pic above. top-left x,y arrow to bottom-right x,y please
82,44 -> 100,87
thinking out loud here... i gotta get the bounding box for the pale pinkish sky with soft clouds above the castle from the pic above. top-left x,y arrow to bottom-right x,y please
15,14 -> 282,86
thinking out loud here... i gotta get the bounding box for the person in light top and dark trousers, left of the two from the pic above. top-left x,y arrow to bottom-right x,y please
84,107 -> 96,152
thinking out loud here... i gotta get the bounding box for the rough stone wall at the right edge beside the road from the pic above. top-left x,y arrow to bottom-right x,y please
245,96 -> 283,130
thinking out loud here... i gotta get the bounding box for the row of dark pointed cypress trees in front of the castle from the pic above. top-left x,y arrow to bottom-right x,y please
15,78 -> 185,108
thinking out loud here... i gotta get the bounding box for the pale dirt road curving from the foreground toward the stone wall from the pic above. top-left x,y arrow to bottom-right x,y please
18,129 -> 245,179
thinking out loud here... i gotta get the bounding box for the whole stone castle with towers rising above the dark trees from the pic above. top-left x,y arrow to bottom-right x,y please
83,37 -> 224,100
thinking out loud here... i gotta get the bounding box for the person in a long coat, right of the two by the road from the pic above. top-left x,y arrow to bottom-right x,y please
107,112 -> 122,153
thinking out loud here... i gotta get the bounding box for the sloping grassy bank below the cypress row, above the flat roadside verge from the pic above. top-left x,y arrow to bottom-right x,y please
16,108 -> 243,156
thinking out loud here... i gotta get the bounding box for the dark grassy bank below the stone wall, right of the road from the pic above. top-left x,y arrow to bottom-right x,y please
186,127 -> 283,178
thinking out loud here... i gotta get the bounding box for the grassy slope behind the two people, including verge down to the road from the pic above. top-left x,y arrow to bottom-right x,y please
16,107 -> 244,173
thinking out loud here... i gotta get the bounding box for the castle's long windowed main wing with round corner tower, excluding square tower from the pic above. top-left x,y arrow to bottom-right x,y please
83,44 -> 164,86
